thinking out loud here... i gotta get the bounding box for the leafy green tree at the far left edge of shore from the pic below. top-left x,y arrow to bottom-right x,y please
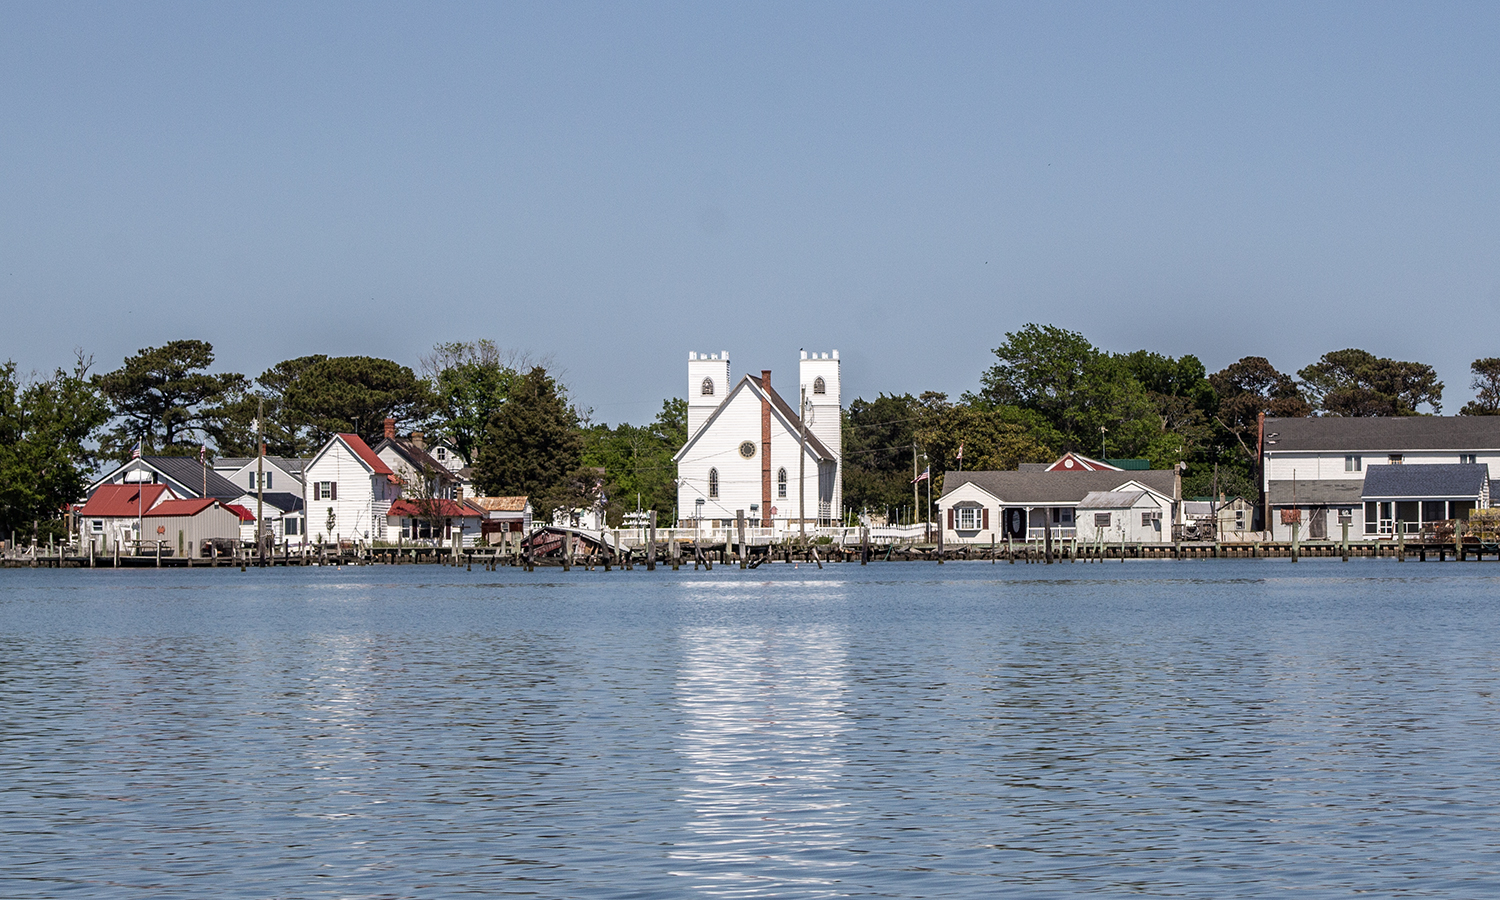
0,356 -> 110,536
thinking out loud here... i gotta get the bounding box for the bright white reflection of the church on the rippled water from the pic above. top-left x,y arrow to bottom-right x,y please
671,588 -> 855,896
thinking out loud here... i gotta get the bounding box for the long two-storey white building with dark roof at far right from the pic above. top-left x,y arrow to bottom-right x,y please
1260,416 -> 1500,540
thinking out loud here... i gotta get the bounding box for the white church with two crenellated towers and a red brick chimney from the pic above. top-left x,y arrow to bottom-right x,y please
674,350 -> 843,531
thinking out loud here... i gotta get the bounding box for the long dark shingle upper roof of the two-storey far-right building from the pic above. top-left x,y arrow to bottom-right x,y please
1266,416 -> 1500,453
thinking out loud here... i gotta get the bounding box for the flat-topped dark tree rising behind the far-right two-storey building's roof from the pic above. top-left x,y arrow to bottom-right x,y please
1298,348 -> 1443,416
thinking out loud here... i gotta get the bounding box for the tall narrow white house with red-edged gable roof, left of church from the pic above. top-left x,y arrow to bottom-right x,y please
303,434 -> 401,542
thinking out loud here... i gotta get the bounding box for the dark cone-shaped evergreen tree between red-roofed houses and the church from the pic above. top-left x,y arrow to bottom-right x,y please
474,366 -> 587,507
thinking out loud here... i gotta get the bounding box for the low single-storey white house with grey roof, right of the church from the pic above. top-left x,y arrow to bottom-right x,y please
938,470 -> 1182,545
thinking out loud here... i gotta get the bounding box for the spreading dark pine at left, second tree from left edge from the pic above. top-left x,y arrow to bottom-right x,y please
95,341 -> 246,461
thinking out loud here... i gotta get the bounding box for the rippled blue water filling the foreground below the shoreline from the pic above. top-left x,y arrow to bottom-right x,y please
0,560 -> 1500,899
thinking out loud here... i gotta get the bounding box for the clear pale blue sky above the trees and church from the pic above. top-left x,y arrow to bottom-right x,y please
0,3 -> 1500,422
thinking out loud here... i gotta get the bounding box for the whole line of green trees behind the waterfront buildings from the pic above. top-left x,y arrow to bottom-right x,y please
0,324 -> 1500,534
